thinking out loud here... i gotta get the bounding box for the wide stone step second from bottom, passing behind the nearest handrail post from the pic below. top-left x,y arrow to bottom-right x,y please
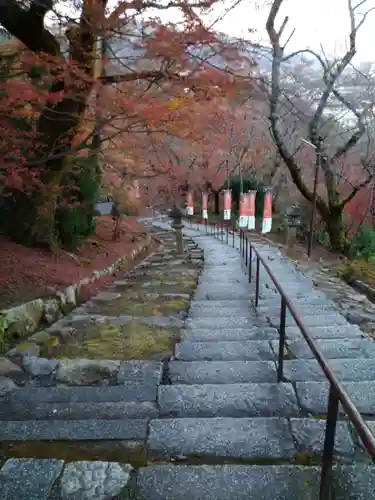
148,417 -> 356,461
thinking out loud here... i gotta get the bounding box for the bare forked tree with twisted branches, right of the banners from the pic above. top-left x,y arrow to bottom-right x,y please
266,0 -> 375,251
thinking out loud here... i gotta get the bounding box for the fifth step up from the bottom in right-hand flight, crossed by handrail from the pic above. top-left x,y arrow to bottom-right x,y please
284,338 -> 375,359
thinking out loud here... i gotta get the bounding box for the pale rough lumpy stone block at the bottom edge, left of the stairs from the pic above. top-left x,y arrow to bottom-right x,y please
61,461 -> 132,500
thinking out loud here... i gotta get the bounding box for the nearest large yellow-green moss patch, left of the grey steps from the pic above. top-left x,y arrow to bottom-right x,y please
42,323 -> 178,360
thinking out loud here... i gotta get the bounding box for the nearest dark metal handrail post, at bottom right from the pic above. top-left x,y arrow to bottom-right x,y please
319,384 -> 339,500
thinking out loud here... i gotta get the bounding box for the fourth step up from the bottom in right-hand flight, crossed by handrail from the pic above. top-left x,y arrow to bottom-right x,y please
284,358 -> 375,382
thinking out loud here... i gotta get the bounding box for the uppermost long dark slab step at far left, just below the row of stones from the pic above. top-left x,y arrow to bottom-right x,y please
6,382 -> 157,404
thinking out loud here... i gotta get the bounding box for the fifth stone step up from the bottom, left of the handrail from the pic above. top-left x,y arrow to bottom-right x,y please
175,340 -> 275,361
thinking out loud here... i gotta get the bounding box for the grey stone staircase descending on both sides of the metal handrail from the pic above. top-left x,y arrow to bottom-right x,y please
138,227 -> 375,500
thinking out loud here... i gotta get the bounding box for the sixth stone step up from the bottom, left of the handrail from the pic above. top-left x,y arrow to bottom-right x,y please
180,327 -> 280,342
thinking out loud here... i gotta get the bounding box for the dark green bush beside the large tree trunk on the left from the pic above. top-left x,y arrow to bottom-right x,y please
56,158 -> 101,250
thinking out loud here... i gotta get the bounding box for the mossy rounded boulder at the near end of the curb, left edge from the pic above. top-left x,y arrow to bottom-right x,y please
3,299 -> 44,338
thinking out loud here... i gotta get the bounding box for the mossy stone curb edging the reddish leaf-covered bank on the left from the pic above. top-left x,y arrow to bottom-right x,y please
0,235 -> 154,356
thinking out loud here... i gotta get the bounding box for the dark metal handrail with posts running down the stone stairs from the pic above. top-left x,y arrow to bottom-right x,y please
189,221 -> 375,500
